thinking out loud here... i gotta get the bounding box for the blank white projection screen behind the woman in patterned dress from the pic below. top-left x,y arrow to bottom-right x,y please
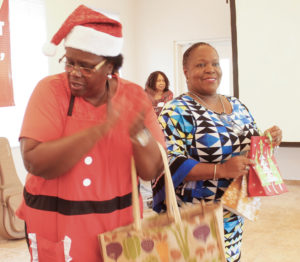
236,0 -> 300,142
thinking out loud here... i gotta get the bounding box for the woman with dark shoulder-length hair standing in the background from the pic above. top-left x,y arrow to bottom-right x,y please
145,71 -> 173,116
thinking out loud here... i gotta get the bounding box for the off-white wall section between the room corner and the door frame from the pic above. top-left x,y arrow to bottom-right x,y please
135,0 -> 231,90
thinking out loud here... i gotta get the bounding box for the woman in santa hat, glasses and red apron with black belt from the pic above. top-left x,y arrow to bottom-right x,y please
17,5 -> 164,262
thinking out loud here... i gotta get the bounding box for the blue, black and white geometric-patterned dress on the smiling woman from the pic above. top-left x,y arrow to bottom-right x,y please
152,94 -> 258,261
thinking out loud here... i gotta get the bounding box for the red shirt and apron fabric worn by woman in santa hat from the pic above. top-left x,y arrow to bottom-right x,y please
18,74 -> 164,262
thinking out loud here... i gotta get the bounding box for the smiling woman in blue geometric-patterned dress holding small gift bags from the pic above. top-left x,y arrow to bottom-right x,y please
153,42 -> 282,262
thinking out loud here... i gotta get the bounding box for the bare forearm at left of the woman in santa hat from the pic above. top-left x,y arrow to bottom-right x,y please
21,125 -> 106,179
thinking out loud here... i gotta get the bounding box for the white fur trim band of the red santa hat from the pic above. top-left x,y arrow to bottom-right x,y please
64,25 -> 123,56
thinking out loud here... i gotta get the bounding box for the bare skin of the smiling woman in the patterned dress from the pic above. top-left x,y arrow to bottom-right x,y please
183,45 -> 282,181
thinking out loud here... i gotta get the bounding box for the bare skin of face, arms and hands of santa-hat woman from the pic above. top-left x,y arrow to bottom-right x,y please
20,48 -> 163,181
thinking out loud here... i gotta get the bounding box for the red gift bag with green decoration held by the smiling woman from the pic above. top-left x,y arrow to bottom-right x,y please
248,136 -> 287,196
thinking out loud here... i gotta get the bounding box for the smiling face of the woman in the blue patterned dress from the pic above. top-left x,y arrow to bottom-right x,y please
183,45 -> 222,96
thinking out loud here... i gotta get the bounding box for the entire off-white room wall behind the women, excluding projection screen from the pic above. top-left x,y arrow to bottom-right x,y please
12,0 -> 300,182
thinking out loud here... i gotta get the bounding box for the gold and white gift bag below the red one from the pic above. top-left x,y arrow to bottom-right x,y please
221,176 -> 261,221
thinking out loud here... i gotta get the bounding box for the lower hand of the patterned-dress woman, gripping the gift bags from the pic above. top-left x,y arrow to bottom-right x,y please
217,156 -> 255,178
